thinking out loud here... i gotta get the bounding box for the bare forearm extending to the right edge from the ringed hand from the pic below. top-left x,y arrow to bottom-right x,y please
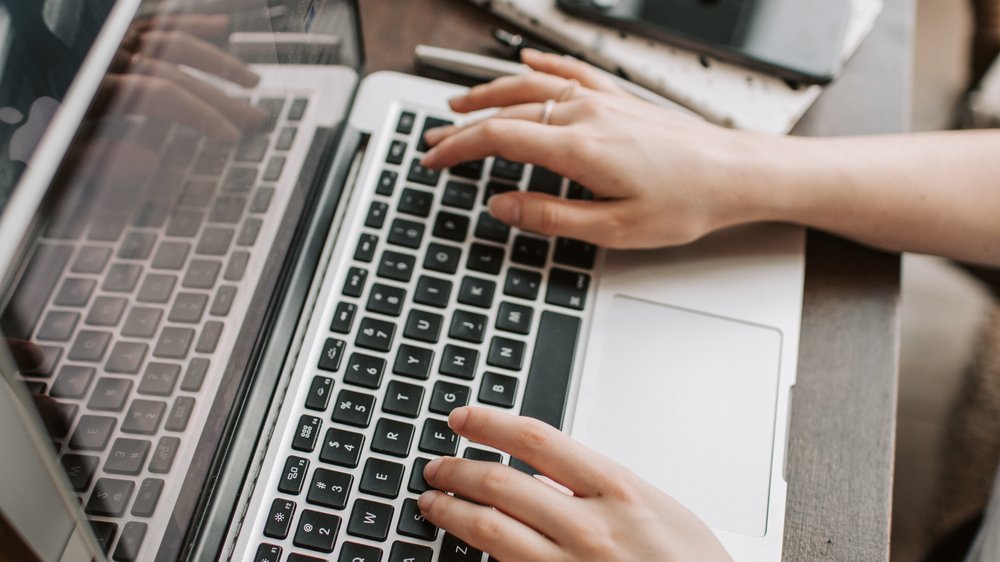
755,131 -> 1000,265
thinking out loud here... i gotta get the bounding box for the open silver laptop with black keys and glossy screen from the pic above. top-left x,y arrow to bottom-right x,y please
0,0 -> 804,562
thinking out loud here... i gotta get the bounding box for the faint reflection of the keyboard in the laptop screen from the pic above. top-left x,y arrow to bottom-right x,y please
4,97 -> 311,561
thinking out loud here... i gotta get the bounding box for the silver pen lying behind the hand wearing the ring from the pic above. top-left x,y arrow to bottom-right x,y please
414,45 -> 701,119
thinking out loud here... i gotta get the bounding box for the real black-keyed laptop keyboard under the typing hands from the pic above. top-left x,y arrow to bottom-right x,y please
246,110 -> 597,562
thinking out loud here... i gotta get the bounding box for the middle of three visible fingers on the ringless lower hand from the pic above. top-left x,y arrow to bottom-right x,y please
424,458 -> 578,542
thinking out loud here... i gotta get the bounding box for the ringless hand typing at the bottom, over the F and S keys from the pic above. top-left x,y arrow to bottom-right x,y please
419,407 -> 731,562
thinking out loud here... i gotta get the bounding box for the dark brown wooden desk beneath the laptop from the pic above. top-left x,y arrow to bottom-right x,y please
361,0 -> 913,561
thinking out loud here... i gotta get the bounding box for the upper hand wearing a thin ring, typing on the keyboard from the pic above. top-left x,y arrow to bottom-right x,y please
424,50 -> 793,248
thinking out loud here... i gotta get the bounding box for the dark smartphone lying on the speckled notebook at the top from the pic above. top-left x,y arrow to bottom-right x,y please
557,0 -> 851,84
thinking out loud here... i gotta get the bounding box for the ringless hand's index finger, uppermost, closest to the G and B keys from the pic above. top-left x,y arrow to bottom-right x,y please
448,407 -> 622,497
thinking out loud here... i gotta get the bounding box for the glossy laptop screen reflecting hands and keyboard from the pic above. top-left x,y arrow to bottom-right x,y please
0,0 -> 362,560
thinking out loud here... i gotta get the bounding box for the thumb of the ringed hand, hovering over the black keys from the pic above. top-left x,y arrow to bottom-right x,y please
489,191 -> 620,245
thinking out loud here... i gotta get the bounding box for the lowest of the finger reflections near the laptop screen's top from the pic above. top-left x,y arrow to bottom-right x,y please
101,74 -> 240,142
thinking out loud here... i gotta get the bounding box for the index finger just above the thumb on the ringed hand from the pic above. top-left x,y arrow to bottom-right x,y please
422,119 -> 572,171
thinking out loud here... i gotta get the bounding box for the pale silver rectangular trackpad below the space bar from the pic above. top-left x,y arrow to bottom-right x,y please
582,296 -> 781,536
